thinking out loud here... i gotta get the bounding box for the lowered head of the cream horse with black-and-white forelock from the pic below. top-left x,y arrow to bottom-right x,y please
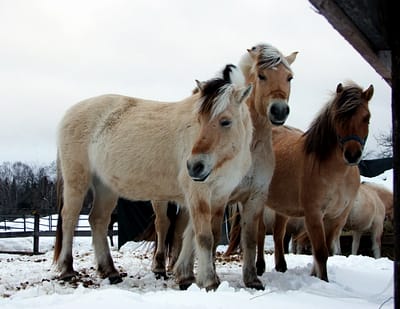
187,66 -> 252,181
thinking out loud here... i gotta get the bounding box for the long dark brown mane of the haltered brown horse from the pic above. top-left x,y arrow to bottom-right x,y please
303,83 -> 363,161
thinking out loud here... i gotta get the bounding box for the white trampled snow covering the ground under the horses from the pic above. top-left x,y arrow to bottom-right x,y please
0,171 -> 394,309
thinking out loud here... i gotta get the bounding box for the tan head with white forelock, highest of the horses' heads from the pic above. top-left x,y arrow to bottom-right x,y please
240,44 -> 297,125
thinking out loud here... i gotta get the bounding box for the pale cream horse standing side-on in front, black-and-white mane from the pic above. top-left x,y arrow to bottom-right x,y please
54,66 -> 253,289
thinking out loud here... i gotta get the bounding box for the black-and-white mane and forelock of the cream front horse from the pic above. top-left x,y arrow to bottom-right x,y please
196,64 -> 244,119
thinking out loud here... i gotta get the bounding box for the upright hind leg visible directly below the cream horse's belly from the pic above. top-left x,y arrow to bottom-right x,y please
151,201 -> 170,278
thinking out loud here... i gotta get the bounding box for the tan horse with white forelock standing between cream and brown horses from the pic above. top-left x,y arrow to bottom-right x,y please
174,44 -> 297,290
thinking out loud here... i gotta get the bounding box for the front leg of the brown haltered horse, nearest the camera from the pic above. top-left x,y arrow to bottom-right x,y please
304,210 -> 329,281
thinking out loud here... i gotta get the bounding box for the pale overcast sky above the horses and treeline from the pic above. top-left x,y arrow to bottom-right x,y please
0,0 -> 391,164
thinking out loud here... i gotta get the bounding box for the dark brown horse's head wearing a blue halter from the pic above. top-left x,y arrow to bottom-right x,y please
332,84 -> 374,165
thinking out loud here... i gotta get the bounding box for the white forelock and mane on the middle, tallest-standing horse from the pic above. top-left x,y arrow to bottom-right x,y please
239,44 -> 292,76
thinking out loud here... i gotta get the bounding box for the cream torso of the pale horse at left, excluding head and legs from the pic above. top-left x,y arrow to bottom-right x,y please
58,95 -> 195,201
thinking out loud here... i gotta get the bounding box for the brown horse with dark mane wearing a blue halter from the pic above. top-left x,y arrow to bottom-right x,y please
257,83 -> 373,281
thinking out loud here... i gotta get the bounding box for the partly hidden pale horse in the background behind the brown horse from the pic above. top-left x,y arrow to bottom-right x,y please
338,182 -> 393,258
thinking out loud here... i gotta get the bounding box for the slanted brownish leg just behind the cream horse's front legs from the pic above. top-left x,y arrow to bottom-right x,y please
168,206 -> 189,271
